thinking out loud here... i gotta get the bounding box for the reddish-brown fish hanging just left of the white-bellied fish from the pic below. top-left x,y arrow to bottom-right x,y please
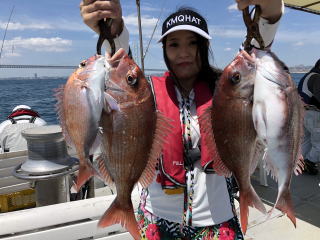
208,51 -> 266,233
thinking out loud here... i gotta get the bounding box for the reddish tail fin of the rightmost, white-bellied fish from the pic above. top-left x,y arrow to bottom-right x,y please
271,189 -> 297,228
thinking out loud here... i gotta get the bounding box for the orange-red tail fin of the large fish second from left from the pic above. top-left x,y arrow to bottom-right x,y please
98,198 -> 141,240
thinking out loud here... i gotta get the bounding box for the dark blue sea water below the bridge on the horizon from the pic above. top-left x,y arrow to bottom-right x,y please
0,73 -> 304,124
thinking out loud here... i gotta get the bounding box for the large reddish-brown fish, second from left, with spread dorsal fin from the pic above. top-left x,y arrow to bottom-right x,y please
99,49 -> 170,239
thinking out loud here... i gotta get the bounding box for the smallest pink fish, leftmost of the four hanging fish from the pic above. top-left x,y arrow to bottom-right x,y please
57,56 -> 106,190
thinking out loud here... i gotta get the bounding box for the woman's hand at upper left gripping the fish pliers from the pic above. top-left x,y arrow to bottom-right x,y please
80,0 -> 123,36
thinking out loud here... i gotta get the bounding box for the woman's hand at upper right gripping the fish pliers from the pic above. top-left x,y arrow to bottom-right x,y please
236,0 -> 282,23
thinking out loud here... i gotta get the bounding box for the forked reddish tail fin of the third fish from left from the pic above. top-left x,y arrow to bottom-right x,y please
240,186 -> 266,234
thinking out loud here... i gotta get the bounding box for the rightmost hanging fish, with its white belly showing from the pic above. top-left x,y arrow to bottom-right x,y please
253,50 -> 303,225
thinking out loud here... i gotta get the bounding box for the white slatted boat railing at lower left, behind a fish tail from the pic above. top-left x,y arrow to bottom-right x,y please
0,189 -> 139,240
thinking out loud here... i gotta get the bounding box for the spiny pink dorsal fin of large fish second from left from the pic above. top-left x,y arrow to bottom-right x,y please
139,111 -> 172,188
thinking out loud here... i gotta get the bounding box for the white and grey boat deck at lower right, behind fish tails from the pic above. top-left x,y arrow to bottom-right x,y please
245,166 -> 320,240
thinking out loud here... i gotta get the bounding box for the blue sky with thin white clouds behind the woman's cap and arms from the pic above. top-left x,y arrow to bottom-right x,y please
0,0 -> 320,78
